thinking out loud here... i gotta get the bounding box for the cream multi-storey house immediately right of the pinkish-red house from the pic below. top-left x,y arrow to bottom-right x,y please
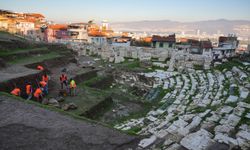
68,23 -> 88,41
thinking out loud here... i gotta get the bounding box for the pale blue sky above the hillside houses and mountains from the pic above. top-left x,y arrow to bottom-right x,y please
0,0 -> 250,22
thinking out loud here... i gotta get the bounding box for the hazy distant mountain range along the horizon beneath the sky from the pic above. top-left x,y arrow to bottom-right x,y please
111,19 -> 250,37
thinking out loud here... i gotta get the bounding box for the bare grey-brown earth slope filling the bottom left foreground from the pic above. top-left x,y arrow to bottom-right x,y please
0,96 -> 138,150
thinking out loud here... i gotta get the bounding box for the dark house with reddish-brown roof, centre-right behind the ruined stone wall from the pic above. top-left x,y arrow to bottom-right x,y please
151,34 -> 176,48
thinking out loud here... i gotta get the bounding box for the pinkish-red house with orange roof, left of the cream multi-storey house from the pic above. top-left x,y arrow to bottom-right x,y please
44,24 -> 67,43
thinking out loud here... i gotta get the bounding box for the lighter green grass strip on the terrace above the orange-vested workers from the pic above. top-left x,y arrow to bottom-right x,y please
8,52 -> 61,65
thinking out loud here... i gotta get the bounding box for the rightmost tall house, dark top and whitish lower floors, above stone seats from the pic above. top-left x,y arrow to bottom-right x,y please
213,35 -> 239,59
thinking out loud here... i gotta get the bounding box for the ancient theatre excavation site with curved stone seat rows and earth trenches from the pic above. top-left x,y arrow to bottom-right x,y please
0,26 -> 250,150
